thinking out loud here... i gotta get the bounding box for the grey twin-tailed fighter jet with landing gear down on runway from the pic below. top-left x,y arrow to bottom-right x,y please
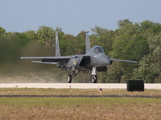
20,31 -> 137,83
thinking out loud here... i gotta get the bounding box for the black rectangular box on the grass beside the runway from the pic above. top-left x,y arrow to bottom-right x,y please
127,80 -> 144,92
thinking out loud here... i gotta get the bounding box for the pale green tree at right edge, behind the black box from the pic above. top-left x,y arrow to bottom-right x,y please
133,35 -> 161,83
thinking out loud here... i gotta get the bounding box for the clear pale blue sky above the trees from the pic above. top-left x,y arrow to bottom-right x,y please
0,0 -> 161,36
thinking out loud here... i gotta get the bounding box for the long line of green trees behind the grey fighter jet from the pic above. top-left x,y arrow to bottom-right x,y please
0,19 -> 161,83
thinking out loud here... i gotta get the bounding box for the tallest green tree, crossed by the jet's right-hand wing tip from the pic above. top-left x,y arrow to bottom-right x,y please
110,20 -> 149,82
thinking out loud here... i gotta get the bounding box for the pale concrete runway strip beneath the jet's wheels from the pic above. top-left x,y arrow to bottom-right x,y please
0,83 -> 161,89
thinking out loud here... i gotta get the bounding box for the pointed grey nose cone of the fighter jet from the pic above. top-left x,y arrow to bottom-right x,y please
97,54 -> 110,66
